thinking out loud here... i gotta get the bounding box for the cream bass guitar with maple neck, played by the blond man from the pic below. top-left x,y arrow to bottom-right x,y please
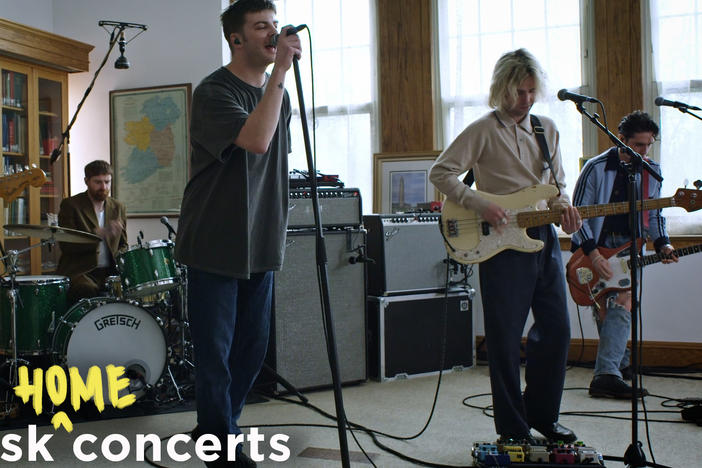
440,185 -> 702,264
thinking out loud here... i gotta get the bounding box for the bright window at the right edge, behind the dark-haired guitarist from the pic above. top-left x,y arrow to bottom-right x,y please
645,0 -> 702,234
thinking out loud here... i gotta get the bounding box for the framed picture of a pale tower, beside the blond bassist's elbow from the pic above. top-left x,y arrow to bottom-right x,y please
373,151 -> 441,213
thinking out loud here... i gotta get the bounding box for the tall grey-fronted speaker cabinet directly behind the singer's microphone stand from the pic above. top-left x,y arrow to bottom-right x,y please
267,229 -> 367,390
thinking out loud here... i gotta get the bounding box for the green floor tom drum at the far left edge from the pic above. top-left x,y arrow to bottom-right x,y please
0,275 -> 69,355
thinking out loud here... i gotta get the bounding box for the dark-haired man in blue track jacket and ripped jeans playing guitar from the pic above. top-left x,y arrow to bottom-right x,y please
571,111 -> 678,399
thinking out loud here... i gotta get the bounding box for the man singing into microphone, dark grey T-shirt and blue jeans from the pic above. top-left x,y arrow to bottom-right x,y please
175,0 -> 301,467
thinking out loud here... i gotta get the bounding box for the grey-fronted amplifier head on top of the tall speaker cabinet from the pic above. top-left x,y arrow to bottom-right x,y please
288,188 -> 361,229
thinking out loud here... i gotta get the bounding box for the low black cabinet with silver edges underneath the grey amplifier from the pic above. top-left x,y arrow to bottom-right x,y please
368,292 -> 473,381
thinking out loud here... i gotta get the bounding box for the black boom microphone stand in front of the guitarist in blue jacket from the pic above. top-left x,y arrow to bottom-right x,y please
576,103 -> 663,468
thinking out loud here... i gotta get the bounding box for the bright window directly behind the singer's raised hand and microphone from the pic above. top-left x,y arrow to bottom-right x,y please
276,0 -> 377,213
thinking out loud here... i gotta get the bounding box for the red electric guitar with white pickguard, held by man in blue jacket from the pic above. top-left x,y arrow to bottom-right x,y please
566,239 -> 702,306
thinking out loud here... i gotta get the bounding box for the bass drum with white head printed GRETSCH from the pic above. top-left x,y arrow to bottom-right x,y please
52,297 -> 167,405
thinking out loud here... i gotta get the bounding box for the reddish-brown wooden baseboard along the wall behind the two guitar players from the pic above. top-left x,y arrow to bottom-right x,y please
475,335 -> 702,370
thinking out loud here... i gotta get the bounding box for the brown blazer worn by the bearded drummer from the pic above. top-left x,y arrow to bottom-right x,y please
56,191 -> 129,276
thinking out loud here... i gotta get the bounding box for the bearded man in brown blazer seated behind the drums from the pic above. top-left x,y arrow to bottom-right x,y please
56,160 -> 128,304
